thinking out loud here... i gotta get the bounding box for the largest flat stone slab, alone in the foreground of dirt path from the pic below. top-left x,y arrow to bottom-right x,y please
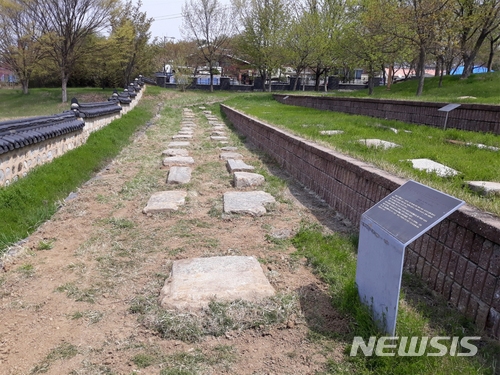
159,256 -> 275,310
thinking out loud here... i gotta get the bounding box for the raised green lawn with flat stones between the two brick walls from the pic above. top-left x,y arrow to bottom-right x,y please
225,93 -> 500,215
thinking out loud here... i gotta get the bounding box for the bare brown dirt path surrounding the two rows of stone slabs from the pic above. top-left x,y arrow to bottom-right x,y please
0,94 -> 349,375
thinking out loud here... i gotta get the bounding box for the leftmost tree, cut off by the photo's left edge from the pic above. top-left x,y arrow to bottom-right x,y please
0,0 -> 43,94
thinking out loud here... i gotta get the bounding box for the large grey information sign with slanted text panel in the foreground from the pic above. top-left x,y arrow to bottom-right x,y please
356,181 -> 464,335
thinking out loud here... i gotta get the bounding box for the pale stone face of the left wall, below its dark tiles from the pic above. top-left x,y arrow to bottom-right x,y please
0,90 -> 144,186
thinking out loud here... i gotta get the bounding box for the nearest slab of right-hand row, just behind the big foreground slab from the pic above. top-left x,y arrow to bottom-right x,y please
224,191 -> 276,216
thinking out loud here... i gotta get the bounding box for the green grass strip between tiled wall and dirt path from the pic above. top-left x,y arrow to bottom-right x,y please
0,87 -> 160,254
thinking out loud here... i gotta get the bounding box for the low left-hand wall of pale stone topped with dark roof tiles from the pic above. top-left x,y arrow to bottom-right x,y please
0,78 -> 143,187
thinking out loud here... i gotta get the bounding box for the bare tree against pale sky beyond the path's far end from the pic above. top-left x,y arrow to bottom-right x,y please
182,0 -> 236,92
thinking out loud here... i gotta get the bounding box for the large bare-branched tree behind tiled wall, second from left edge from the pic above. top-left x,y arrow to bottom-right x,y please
23,0 -> 118,103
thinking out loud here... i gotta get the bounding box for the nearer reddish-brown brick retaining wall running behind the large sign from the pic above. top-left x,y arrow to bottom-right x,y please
221,105 -> 500,339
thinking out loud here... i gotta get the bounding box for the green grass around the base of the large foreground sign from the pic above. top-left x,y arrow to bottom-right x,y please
293,224 -> 500,375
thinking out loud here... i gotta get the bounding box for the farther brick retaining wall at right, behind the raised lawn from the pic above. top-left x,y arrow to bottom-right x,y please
274,94 -> 500,134
